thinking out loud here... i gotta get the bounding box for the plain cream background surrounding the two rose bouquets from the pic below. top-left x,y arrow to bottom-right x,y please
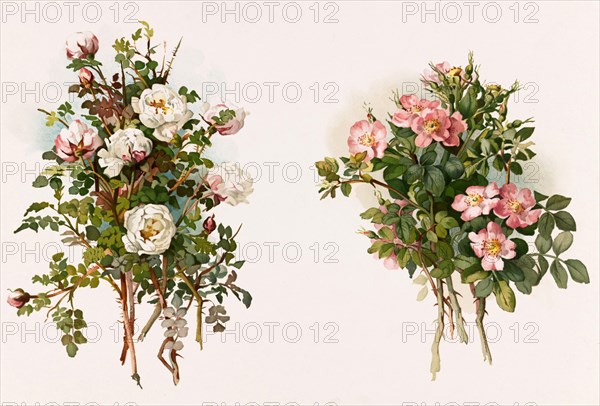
0,1 -> 599,405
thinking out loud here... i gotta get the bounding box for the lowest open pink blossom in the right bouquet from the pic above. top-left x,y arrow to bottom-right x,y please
469,221 -> 517,271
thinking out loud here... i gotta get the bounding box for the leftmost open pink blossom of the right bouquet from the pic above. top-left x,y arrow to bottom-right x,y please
348,120 -> 387,161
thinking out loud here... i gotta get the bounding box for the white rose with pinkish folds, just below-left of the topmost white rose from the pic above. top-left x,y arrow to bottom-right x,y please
98,128 -> 152,178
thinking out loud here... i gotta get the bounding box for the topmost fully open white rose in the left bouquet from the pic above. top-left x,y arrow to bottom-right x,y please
131,84 -> 193,142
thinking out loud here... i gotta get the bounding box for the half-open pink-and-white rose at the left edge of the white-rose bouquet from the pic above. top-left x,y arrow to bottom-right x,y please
54,120 -> 102,162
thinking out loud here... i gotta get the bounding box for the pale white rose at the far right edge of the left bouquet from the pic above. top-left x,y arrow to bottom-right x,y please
206,163 -> 254,206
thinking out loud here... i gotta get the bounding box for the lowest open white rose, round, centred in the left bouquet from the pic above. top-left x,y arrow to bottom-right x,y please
123,204 -> 176,255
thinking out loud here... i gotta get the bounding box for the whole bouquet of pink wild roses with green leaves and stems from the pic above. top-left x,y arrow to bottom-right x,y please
316,54 -> 589,379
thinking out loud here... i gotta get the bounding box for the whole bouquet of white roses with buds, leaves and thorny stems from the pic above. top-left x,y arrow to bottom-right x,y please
8,22 -> 253,386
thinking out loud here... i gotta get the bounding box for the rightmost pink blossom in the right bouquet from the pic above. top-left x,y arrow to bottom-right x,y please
494,183 -> 542,228
